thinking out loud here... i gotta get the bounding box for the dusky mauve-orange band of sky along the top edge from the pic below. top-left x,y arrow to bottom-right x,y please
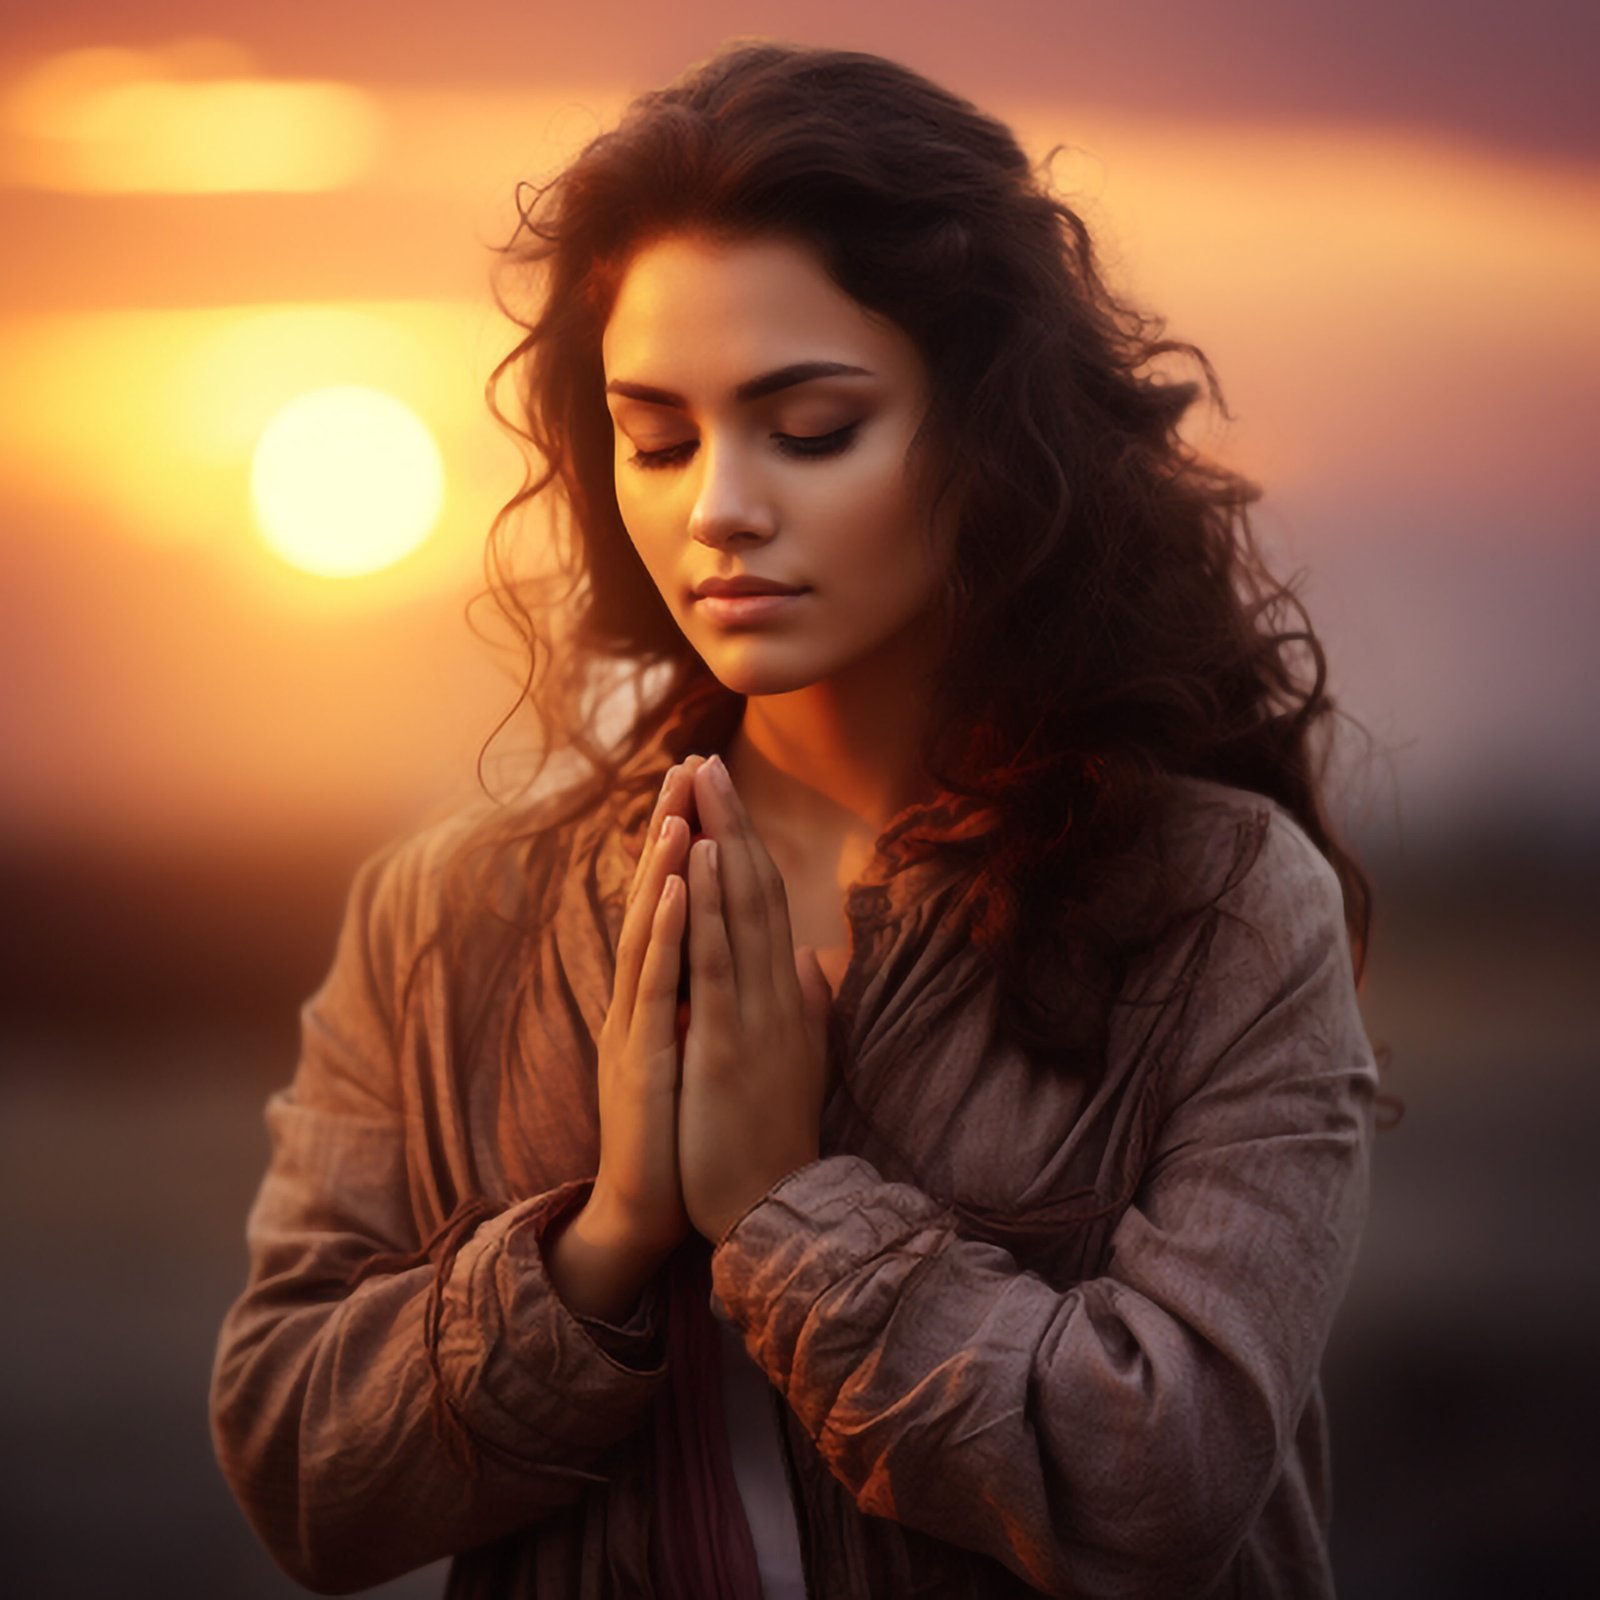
0,0 -> 1600,160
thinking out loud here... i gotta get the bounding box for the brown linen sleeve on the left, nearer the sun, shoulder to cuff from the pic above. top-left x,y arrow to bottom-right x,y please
211,846 -> 666,1594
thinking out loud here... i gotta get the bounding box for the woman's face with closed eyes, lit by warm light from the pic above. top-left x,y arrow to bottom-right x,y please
602,235 -> 949,694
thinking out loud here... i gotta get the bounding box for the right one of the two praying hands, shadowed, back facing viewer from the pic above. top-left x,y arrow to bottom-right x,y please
678,758 -> 834,1245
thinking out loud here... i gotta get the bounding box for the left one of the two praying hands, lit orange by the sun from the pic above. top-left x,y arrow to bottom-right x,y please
586,755 -> 704,1259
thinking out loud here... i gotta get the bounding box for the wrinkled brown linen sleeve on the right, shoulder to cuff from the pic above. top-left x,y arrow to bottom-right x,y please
712,808 -> 1376,1600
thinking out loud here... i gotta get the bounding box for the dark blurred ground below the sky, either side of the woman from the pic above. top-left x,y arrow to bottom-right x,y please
0,827 -> 1600,1600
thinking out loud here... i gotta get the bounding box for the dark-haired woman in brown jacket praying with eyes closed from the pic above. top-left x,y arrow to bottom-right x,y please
213,43 -> 1376,1600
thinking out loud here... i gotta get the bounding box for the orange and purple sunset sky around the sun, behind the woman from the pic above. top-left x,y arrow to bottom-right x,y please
0,0 -> 1600,846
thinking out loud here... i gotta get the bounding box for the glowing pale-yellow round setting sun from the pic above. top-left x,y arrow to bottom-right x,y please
250,386 -> 445,578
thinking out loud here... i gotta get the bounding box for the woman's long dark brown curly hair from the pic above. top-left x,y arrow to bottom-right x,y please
448,40 -> 1373,1081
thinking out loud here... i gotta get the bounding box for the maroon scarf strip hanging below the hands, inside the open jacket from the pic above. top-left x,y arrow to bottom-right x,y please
651,1234 -> 762,1600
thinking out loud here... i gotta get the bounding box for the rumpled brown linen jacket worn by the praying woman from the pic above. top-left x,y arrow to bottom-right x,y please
211,681 -> 1376,1600
